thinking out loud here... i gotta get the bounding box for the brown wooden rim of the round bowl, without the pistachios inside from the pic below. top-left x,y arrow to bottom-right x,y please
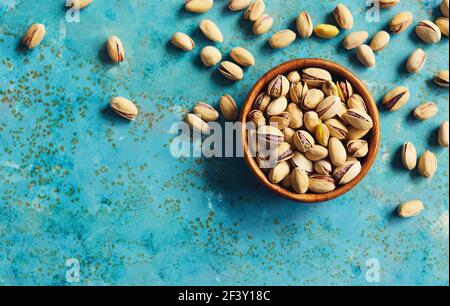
241,59 -> 380,203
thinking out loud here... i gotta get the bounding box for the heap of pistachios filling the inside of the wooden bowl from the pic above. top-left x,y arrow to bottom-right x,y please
248,67 -> 373,194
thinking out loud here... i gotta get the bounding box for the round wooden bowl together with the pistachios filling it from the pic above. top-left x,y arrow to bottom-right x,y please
241,59 -> 380,203
